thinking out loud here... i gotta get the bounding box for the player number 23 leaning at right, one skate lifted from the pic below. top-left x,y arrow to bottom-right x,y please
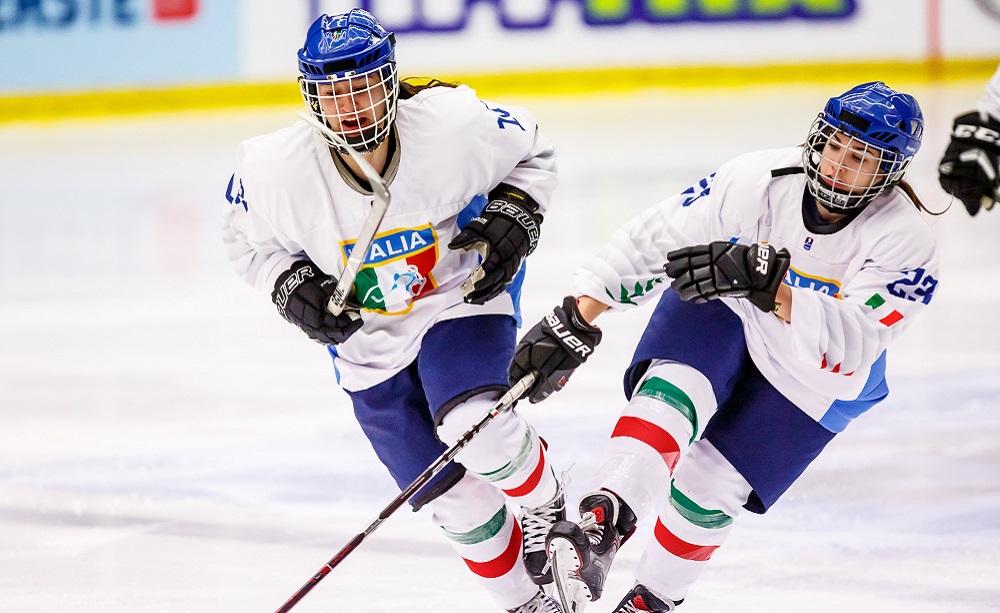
510,82 -> 938,613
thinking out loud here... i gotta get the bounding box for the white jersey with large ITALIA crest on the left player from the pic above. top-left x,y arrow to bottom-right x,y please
223,87 -> 557,391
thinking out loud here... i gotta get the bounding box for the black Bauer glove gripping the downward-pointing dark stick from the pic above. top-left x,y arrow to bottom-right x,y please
507,296 -> 601,404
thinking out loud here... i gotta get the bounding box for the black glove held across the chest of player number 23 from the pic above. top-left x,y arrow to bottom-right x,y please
663,241 -> 792,312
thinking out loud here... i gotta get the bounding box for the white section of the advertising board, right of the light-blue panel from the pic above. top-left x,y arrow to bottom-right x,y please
244,0 -> 1000,79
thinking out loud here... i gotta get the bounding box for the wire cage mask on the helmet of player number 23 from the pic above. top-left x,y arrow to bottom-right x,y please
802,113 -> 913,213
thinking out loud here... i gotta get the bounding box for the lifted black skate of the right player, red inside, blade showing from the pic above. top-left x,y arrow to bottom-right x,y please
546,490 -> 636,611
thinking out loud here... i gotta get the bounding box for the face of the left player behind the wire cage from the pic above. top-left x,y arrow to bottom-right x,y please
318,71 -> 388,145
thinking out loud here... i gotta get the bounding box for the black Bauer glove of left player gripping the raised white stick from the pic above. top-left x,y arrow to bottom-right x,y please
271,260 -> 364,345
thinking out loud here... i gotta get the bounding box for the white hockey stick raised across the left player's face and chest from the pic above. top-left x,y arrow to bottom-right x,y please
298,111 -> 389,315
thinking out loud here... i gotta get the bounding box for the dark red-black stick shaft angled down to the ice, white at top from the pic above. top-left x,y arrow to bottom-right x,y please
276,373 -> 535,613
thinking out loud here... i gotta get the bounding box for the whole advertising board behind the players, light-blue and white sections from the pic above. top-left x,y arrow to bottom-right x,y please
0,0 -> 1000,96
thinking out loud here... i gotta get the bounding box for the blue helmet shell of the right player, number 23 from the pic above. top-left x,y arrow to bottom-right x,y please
823,81 -> 924,157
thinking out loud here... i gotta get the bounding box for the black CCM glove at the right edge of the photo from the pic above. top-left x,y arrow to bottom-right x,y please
938,112 -> 1000,215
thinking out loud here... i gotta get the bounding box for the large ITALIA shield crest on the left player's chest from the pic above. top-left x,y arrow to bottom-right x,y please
340,224 -> 438,315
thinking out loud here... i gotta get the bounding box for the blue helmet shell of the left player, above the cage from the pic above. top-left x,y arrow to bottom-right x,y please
298,9 -> 396,81
